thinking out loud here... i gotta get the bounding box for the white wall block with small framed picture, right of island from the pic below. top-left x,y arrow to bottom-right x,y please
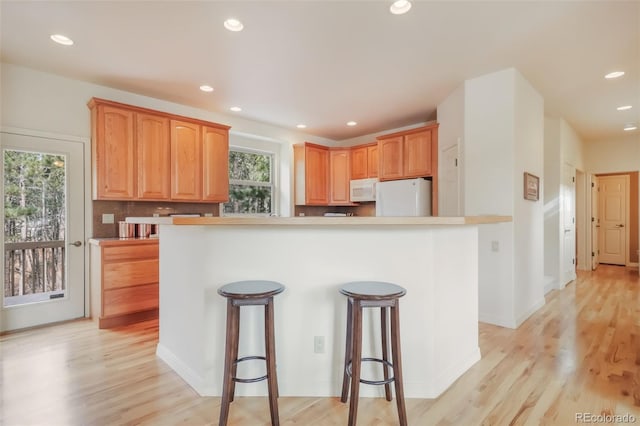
463,69 -> 544,327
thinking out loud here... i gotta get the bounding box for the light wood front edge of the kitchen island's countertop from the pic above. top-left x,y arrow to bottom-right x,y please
173,216 -> 513,226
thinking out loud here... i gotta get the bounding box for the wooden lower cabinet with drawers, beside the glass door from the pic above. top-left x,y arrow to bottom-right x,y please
90,239 -> 159,328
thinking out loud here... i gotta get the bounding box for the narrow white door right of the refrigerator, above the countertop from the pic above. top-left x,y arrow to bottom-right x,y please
438,145 -> 462,216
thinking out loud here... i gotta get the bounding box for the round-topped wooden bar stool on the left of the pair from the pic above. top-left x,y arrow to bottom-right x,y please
218,281 -> 284,426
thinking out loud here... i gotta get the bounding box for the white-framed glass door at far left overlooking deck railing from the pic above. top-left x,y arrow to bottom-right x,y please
0,132 -> 85,331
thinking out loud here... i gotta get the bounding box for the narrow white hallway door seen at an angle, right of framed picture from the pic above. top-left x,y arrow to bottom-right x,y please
560,164 -> 576,286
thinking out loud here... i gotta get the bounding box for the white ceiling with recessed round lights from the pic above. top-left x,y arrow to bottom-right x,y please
0,0 -> 640,140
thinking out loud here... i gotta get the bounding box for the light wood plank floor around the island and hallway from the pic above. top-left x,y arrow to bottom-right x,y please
0,265 -> 640,426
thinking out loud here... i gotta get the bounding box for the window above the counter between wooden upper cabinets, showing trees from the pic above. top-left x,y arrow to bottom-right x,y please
222,148 -> 275,216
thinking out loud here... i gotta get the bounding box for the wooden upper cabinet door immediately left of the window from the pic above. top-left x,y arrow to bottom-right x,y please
202,126 -> 229,202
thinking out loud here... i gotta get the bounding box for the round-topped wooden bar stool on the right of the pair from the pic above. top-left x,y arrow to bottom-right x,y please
340,281 -> 407,426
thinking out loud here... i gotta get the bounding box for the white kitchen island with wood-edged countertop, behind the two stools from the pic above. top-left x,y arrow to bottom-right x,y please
157,216 -> 511,398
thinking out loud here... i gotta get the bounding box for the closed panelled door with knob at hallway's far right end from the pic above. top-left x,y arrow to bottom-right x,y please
599,175 -> 629,265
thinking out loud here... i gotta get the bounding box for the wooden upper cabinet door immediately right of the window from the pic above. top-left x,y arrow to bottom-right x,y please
304,145 -> 329,205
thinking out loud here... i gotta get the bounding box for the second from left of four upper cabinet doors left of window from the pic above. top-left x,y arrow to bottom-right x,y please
136,113 -> 171,200
